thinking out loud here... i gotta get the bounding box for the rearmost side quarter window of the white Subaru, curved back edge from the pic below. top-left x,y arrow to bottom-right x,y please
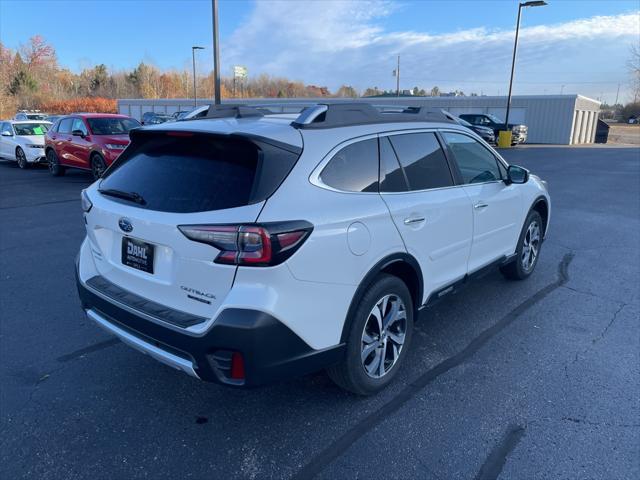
320,138 -> 378,192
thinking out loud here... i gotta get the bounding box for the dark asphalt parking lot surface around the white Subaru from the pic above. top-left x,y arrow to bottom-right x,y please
0,147 -> 640,480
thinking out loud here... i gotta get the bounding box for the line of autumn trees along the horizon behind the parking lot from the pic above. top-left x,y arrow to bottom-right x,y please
0,35 -> 383,117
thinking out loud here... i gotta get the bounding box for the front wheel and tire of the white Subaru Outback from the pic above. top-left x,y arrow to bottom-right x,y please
500,210 -> 544,280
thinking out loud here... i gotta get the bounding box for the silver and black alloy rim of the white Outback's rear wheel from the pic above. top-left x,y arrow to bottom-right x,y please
360,294 -> 407,378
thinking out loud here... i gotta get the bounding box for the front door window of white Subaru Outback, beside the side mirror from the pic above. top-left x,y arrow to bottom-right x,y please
442,132 -> 502,183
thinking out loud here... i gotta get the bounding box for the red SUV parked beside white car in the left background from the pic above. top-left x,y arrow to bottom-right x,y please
45,113 -> 140,180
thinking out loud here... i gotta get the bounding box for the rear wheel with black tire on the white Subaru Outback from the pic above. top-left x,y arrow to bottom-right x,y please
327,274 -> 413,395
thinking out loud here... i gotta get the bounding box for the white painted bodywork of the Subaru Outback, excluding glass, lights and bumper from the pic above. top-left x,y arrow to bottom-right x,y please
79,119 -> 549,349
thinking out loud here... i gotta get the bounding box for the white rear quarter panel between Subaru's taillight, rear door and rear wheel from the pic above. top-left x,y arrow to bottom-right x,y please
252,135 -> 406,349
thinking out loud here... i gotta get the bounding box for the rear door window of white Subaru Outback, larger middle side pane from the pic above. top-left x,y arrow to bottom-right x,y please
389,133 -> 453,190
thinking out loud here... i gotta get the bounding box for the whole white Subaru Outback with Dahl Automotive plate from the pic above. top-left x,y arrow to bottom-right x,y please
77,103 -> 550,394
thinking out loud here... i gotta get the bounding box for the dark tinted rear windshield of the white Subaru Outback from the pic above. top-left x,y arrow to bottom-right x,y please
99,132 -> 298,213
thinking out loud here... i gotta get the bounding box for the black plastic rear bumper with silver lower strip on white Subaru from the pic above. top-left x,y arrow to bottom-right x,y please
76,258 -> 345,387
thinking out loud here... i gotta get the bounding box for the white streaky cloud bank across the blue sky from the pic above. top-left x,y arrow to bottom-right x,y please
223,0 -> 640,100
